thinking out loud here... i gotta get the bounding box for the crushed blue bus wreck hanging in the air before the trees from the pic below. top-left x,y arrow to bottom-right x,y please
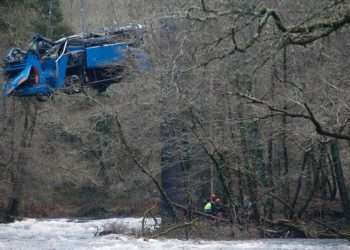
3,25 -> 148,96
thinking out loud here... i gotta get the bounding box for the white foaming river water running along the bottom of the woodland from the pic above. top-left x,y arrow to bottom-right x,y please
0,218 -> 350,250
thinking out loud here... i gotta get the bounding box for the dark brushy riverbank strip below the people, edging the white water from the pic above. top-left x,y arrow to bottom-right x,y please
150,220 -> 350,240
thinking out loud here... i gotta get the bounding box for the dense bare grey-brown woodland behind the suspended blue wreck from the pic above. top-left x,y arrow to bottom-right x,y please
0,0 -> 350,237
